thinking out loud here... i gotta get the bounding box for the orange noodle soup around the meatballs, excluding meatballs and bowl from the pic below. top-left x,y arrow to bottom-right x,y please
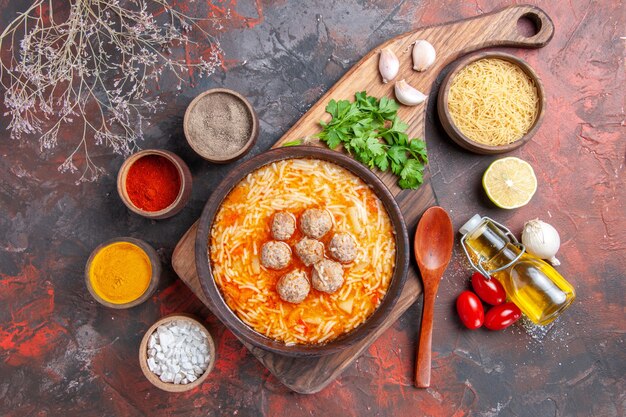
208,159 -> 396,345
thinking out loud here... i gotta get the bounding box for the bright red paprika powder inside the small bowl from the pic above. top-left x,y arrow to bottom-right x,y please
126,155 -> 180,211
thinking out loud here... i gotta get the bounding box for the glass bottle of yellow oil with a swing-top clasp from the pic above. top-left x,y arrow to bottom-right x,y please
459,214 -> 576,325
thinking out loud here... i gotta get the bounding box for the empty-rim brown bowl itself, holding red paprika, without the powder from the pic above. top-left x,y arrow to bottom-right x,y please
117,149 -> 192,220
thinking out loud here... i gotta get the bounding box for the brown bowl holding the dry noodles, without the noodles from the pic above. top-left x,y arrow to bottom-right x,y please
437,52 -> 546,155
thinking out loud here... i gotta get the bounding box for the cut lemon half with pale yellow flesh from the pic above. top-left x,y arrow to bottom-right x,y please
483,156 -> 537,209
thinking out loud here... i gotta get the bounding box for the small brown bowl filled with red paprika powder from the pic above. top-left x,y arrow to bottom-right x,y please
117,149 -> 192,219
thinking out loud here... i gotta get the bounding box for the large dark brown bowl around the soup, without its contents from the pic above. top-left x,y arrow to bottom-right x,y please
195,146 -> 409,357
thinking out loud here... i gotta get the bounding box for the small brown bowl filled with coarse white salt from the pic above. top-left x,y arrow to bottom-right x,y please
139,313 -> 215,392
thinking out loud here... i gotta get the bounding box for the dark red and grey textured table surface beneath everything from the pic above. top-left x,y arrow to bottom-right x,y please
0,0 -> 626,416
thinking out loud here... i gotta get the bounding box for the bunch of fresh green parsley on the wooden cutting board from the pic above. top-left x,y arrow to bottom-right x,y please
316,91 -> 428,189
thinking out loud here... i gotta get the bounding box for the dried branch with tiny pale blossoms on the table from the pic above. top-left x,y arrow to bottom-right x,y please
0,0 -> 222,182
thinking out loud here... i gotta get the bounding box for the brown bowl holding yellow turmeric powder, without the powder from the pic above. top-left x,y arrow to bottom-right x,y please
85,237 -> 161,309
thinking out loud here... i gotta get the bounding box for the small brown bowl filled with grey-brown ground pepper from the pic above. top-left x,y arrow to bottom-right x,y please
183,88 -> 259,164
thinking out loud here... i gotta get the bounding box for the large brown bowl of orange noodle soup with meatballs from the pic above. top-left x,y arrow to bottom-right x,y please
195,146 -> 409,356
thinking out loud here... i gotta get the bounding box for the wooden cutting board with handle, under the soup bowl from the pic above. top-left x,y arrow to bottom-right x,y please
172,6 -> 554,394
